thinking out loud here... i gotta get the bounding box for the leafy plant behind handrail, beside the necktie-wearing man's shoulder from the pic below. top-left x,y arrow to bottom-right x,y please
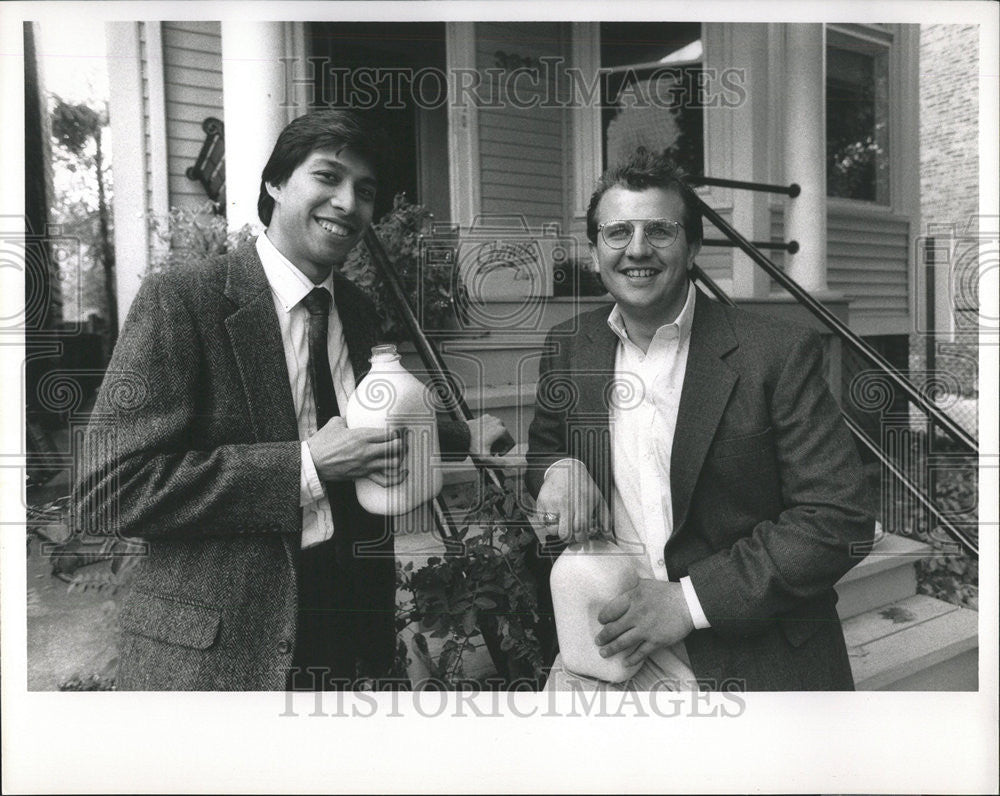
341,193 -> 464,341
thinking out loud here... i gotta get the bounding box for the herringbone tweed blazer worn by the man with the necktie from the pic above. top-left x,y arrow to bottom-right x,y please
77,242 -> 467,690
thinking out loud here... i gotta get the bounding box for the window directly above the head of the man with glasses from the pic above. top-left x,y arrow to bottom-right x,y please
600,22 -> 704,174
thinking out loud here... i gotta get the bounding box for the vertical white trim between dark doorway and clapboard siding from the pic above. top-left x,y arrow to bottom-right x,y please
445,22 -> 482,228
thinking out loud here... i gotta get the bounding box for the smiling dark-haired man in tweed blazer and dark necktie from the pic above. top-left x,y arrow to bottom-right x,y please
77,110 -> 503,690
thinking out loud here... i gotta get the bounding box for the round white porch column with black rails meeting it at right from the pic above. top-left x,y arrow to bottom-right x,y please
784,24 -> 827,293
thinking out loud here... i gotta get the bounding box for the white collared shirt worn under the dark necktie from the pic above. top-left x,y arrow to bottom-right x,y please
257,233 -> 355,548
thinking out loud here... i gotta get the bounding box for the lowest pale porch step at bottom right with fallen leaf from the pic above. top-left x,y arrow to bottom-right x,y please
843,594 -> 979,691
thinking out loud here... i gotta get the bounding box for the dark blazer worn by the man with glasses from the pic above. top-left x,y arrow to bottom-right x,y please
527,292 -> 874,690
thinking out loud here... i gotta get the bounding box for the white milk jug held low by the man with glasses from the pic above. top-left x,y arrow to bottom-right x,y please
549,539 -> 642,683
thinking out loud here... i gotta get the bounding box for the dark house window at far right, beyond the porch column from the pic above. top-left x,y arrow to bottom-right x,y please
826,30 -> 889,204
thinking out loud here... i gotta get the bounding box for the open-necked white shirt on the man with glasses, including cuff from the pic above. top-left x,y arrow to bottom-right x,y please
608,283 -> 709,628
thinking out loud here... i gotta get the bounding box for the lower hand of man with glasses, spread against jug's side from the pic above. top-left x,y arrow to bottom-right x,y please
596,578 -> 694,666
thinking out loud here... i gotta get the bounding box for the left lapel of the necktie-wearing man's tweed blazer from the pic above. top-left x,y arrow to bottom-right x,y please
225,242 -> 299,442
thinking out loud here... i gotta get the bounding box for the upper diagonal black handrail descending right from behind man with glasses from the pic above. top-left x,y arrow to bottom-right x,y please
680,182 -> 979,455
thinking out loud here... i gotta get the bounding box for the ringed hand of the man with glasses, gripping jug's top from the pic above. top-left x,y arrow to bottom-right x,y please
535,459 -> 611,542
